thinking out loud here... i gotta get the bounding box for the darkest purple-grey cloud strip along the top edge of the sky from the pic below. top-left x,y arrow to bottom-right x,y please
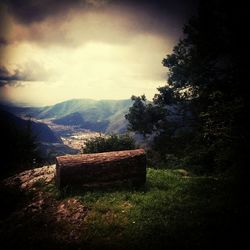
1,0 -> 198,24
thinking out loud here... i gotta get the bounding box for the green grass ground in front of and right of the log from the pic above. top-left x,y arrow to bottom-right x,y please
1,168 -> 246,249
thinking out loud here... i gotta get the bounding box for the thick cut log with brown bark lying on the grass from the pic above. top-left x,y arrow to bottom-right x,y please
56,149 -> 146,188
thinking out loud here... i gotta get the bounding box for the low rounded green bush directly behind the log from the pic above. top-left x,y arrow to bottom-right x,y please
83,134 -> 136,153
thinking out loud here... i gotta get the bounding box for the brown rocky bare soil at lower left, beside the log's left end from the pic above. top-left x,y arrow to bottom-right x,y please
0,165 -> 88,249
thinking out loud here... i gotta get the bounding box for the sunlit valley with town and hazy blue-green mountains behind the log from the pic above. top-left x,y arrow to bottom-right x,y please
0,99 -> 132,159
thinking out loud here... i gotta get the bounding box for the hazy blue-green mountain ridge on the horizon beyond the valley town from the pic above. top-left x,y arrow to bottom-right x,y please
0,99 -> 132,133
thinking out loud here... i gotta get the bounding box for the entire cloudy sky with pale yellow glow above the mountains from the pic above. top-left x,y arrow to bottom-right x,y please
0,0 -> 197,106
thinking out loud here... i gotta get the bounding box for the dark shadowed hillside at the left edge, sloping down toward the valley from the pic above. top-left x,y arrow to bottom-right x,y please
0,109 -> 79,176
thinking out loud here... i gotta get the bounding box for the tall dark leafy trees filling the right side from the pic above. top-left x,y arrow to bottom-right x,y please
126,1 -> 249,171
